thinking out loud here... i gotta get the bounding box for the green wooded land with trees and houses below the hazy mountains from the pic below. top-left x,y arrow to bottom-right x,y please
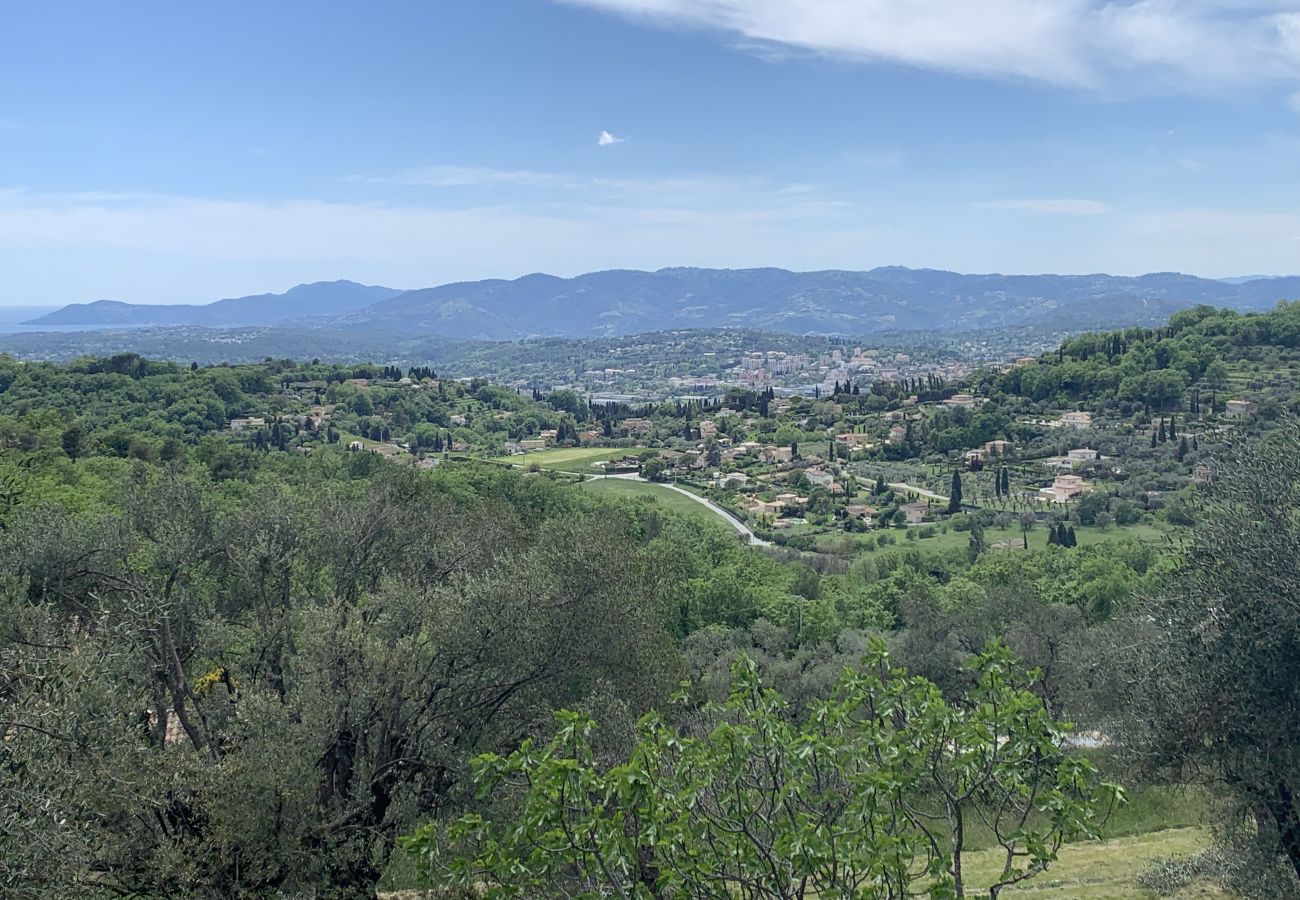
0,314 -> 1300,897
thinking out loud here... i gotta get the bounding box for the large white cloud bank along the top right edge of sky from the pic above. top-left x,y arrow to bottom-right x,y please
564,0 -> 1300,90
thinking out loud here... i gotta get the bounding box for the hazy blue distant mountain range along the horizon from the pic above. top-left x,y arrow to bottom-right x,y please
17,267 -> 1300,341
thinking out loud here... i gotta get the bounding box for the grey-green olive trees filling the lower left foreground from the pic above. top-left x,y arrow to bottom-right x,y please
0,472 -> 675,897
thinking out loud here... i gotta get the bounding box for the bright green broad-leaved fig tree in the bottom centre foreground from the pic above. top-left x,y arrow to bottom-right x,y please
404,641 -> 1119,900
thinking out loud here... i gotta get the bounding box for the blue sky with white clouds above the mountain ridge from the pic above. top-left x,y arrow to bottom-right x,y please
0,0 -> 1300,306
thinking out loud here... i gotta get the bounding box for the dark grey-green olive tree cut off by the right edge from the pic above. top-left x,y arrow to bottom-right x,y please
1102,423 -> 1300,884
